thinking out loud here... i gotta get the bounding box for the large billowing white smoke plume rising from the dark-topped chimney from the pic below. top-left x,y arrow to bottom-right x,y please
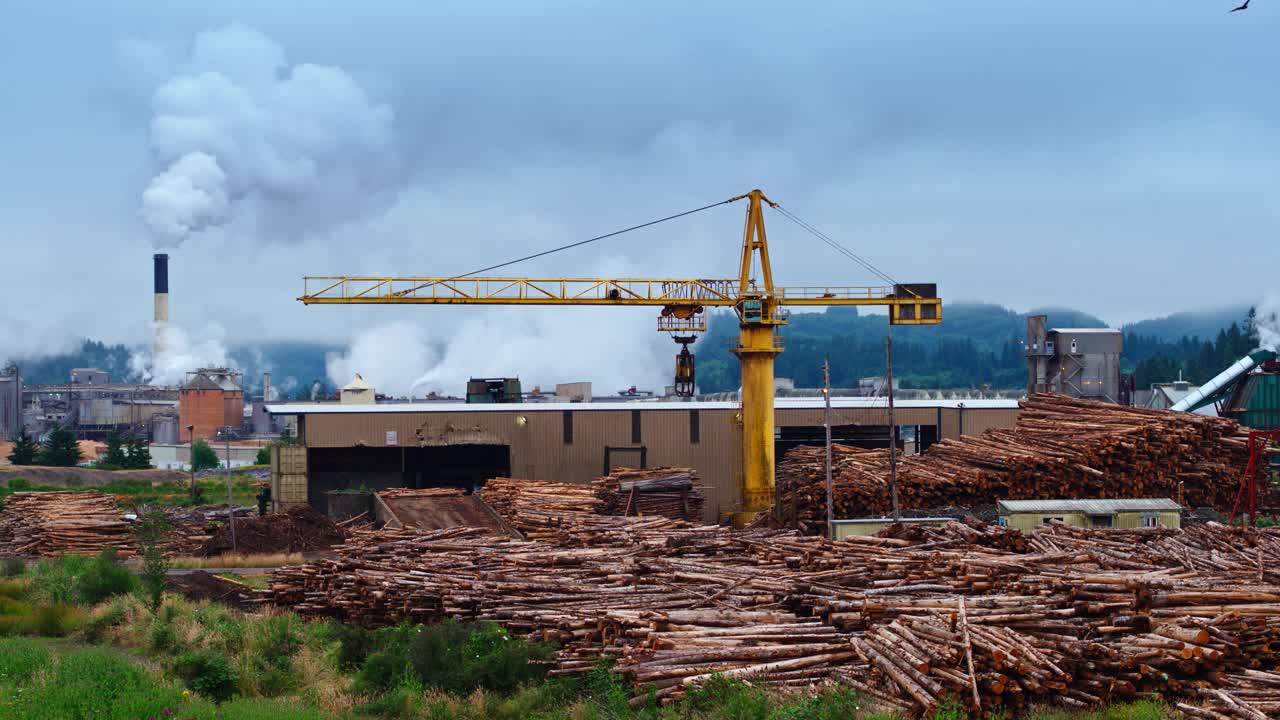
138,26 -> 397,247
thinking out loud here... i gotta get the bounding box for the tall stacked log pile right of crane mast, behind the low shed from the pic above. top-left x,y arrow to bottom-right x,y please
777,393 -> 1248,532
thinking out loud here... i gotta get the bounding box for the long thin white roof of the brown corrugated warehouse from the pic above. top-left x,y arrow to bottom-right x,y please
265,397 -> 1018,415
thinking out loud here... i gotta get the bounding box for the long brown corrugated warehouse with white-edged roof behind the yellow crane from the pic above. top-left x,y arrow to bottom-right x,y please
268,397 -> 1018,521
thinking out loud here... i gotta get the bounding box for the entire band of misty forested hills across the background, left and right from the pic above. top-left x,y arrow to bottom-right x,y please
10,302 -> 1256,398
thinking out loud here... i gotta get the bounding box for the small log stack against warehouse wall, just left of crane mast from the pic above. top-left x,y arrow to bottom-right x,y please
591,468 -> 704,520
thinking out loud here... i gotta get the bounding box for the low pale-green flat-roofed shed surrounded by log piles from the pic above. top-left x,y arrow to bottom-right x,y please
997,498 -> 1183,533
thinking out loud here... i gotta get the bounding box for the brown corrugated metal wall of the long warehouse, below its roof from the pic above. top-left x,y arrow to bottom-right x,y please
300,404 -> 1018,521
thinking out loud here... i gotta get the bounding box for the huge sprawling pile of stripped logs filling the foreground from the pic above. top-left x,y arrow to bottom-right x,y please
264,518 -> 1280,719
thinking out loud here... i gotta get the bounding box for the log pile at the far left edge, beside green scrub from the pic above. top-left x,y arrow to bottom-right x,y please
0,491 -> 136,556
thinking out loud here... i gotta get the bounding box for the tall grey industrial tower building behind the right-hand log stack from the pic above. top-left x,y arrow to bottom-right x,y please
1025,315 -> 1128,405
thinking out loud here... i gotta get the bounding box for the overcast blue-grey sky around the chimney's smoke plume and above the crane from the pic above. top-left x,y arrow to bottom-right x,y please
0,0 -> 1280,363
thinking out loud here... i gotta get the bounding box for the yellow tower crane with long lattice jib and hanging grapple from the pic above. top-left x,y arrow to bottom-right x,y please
298,190 -> 942,515
